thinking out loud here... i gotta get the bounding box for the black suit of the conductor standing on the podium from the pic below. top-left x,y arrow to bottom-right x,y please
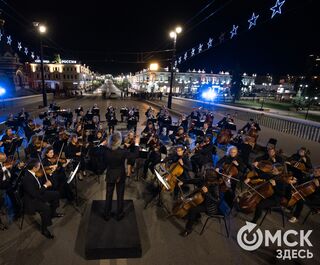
103,146 -> 139,216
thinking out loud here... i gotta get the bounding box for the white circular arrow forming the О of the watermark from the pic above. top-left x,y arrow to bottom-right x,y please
237,222 -> 263,251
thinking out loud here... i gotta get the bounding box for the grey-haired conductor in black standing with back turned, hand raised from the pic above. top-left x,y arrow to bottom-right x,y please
103,132 -> 140,221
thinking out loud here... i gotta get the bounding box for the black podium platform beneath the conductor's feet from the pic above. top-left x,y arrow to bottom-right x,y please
85,200 -> 142,260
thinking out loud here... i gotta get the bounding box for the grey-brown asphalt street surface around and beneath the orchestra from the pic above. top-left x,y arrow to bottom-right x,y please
0,94 -> 320,265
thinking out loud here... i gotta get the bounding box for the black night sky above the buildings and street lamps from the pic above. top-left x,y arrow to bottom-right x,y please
0,0 -> 320,74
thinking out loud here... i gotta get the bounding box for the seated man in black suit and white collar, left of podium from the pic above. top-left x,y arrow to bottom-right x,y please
23,159 -> 64,239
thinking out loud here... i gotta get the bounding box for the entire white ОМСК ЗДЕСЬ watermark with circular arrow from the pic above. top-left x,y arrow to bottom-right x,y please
237,222 -> 313,260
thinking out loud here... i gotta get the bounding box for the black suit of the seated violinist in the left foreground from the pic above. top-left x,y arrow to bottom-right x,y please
23,171 -> 59,228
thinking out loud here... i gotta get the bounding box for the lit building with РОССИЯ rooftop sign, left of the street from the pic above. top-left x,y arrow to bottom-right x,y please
26,60 -> 95,92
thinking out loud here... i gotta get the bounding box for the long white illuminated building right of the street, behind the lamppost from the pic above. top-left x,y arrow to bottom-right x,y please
129,68 -> 255,94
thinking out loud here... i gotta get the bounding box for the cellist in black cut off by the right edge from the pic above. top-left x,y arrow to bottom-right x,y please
289,166 -> 320,223
